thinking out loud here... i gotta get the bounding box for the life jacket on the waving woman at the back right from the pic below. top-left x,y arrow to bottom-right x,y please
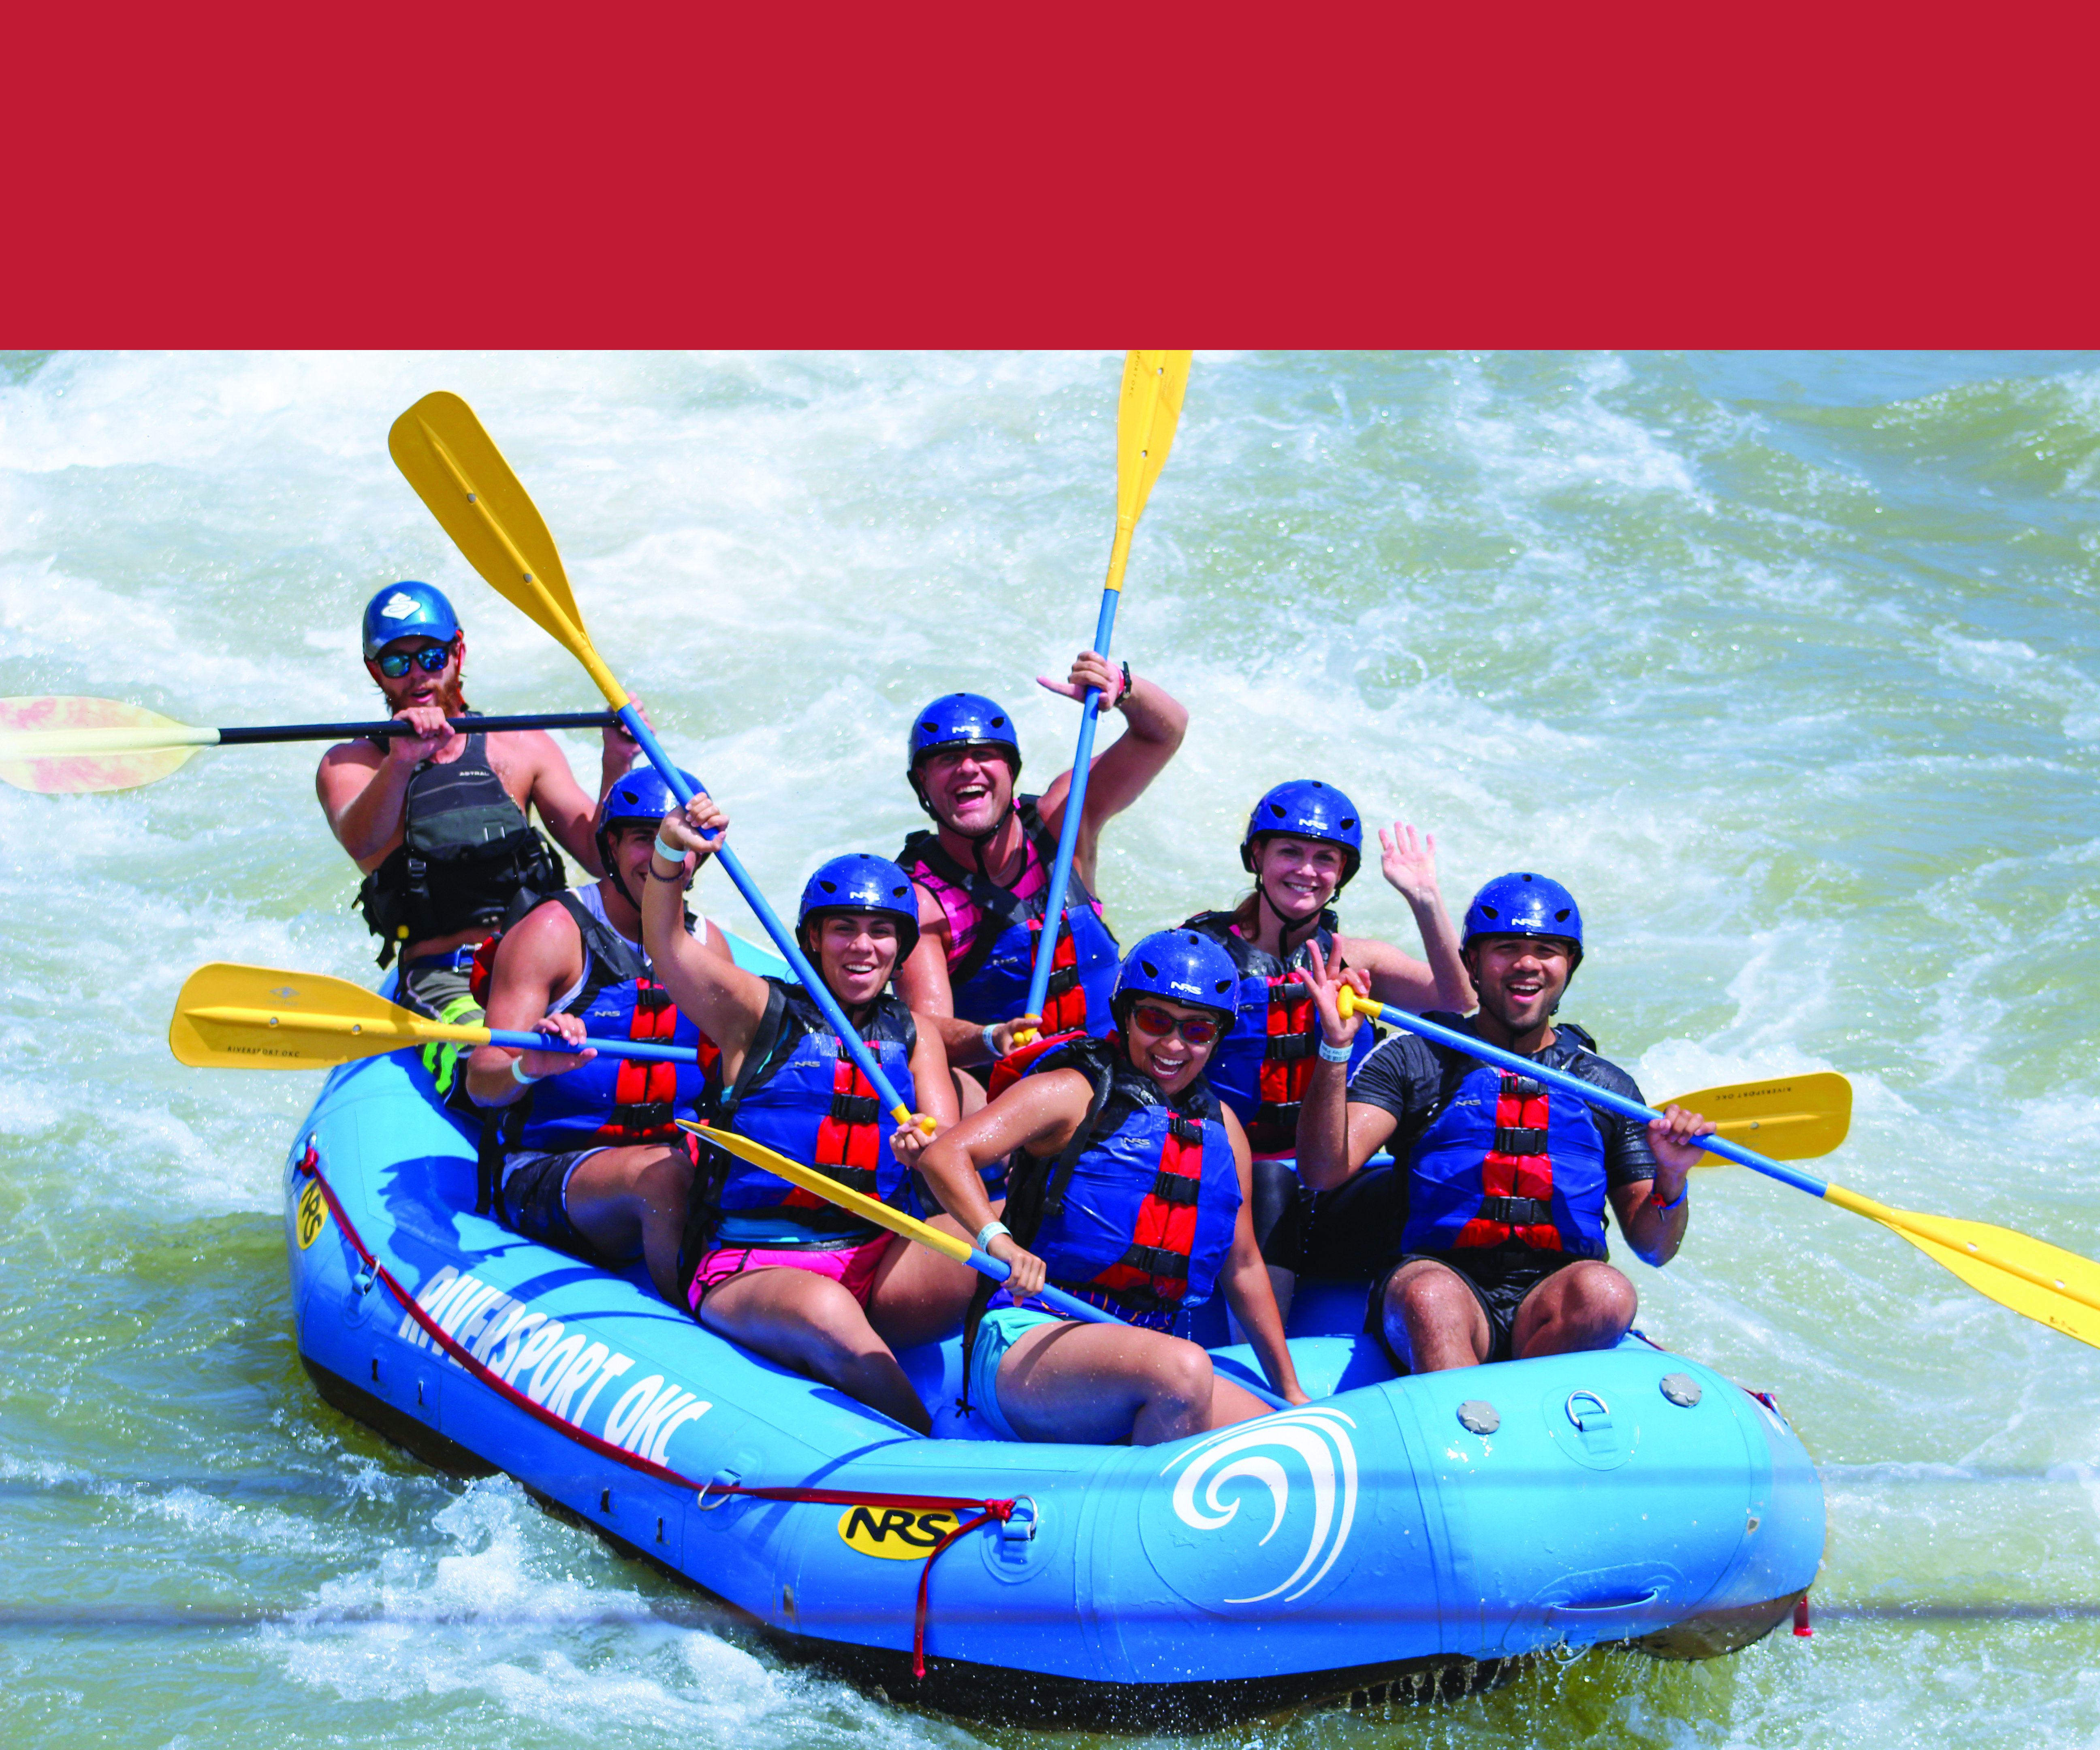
1182,912 -> 1378,1155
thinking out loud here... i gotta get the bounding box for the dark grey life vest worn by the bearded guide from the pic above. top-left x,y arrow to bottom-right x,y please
355,727 -> 569,967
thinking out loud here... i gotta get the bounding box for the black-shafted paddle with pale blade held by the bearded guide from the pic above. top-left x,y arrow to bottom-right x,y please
0,693 -> 619,796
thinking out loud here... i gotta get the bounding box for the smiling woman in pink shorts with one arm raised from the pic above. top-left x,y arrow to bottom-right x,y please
642,792 -> 974,1433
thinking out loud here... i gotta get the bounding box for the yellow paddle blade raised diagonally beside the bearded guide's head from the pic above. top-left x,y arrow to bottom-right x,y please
386,388 -> 628,710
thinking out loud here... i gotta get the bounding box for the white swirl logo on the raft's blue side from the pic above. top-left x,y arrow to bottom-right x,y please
1140,1405 -> 1357,1609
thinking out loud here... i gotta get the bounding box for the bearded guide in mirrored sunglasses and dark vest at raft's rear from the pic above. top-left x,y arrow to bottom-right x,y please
315,582 -> 636,1093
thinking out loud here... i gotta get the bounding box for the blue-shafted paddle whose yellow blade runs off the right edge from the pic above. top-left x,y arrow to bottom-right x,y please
1338,987 -> 2100,1349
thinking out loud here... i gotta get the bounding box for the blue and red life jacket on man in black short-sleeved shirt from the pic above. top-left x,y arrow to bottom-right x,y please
1401,1015 -> 1607,1258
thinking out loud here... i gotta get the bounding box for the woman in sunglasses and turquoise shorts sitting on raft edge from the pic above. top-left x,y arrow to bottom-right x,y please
918,930 -> 1306,1445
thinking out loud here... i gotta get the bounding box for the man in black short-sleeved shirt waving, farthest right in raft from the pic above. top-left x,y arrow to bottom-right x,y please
1268,870 -> 1714,1374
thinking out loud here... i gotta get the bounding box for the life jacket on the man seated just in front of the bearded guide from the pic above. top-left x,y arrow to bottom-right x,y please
481,893 -> 720,1208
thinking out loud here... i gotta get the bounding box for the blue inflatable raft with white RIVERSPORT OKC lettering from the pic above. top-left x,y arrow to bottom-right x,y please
286,975 -> 1823,1725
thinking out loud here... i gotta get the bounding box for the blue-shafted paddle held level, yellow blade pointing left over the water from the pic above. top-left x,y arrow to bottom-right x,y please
168,960 -> 699,1069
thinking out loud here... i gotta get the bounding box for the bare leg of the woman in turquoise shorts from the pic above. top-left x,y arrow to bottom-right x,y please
1000,1321 -> 1226,1445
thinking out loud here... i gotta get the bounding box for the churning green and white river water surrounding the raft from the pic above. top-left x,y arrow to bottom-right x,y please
0,355 -> 2100,1750
